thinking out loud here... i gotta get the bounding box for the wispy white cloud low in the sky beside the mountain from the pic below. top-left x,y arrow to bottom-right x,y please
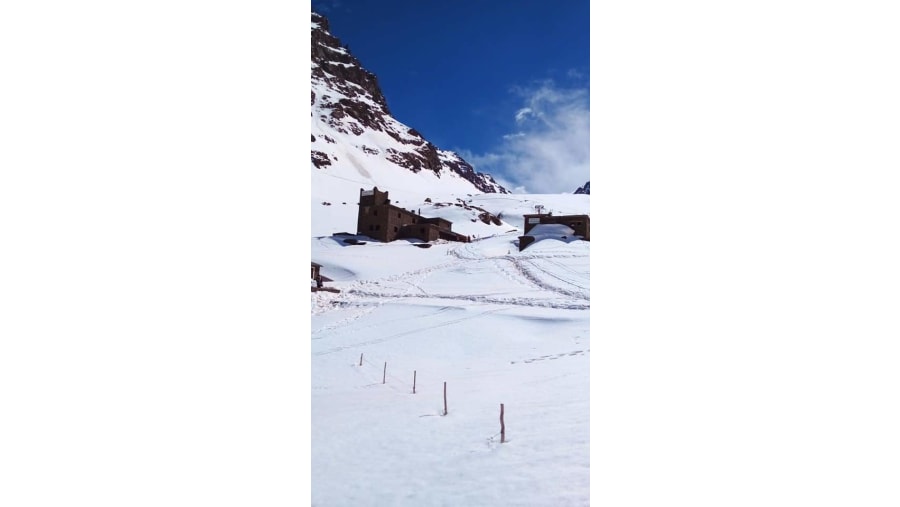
459,81 -> 590,193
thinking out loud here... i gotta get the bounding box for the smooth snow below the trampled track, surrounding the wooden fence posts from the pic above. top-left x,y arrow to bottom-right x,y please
312,302 -> 590,505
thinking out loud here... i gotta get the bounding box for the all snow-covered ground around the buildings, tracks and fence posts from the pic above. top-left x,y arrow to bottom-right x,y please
311,192 -> 590,506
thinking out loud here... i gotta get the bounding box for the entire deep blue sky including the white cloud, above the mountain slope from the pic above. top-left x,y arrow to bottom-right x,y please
312,0 -> 590,193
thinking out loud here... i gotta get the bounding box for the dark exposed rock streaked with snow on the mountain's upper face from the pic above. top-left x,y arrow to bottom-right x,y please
311,12 -> 509,194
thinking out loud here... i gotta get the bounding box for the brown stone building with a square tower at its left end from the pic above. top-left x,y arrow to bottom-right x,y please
356,187 -> 469,243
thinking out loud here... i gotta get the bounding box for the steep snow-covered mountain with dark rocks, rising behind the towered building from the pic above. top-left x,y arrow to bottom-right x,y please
310,12 -> 508,206
